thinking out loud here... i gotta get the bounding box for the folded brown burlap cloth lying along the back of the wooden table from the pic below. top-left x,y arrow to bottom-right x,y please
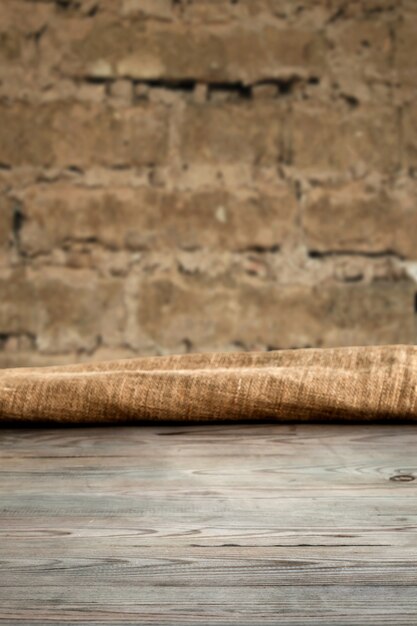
0,345 -> 417,424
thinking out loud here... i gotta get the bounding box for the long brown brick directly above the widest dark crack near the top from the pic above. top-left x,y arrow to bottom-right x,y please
58,19 -> 326,83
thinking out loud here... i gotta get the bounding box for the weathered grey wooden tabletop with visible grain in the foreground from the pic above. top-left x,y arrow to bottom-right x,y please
0,425 -> 417,626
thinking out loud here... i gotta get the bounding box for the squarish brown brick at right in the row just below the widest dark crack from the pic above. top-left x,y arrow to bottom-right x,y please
292,102 -> 399,172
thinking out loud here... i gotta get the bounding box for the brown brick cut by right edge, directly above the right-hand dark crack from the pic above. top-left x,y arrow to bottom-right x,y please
303,182 -> 417,259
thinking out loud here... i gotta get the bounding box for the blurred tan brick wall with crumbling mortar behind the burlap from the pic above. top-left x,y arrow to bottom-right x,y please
0,0 -> 417,367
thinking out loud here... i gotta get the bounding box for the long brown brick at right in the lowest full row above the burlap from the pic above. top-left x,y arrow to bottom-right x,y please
137,276 -> 415,351
